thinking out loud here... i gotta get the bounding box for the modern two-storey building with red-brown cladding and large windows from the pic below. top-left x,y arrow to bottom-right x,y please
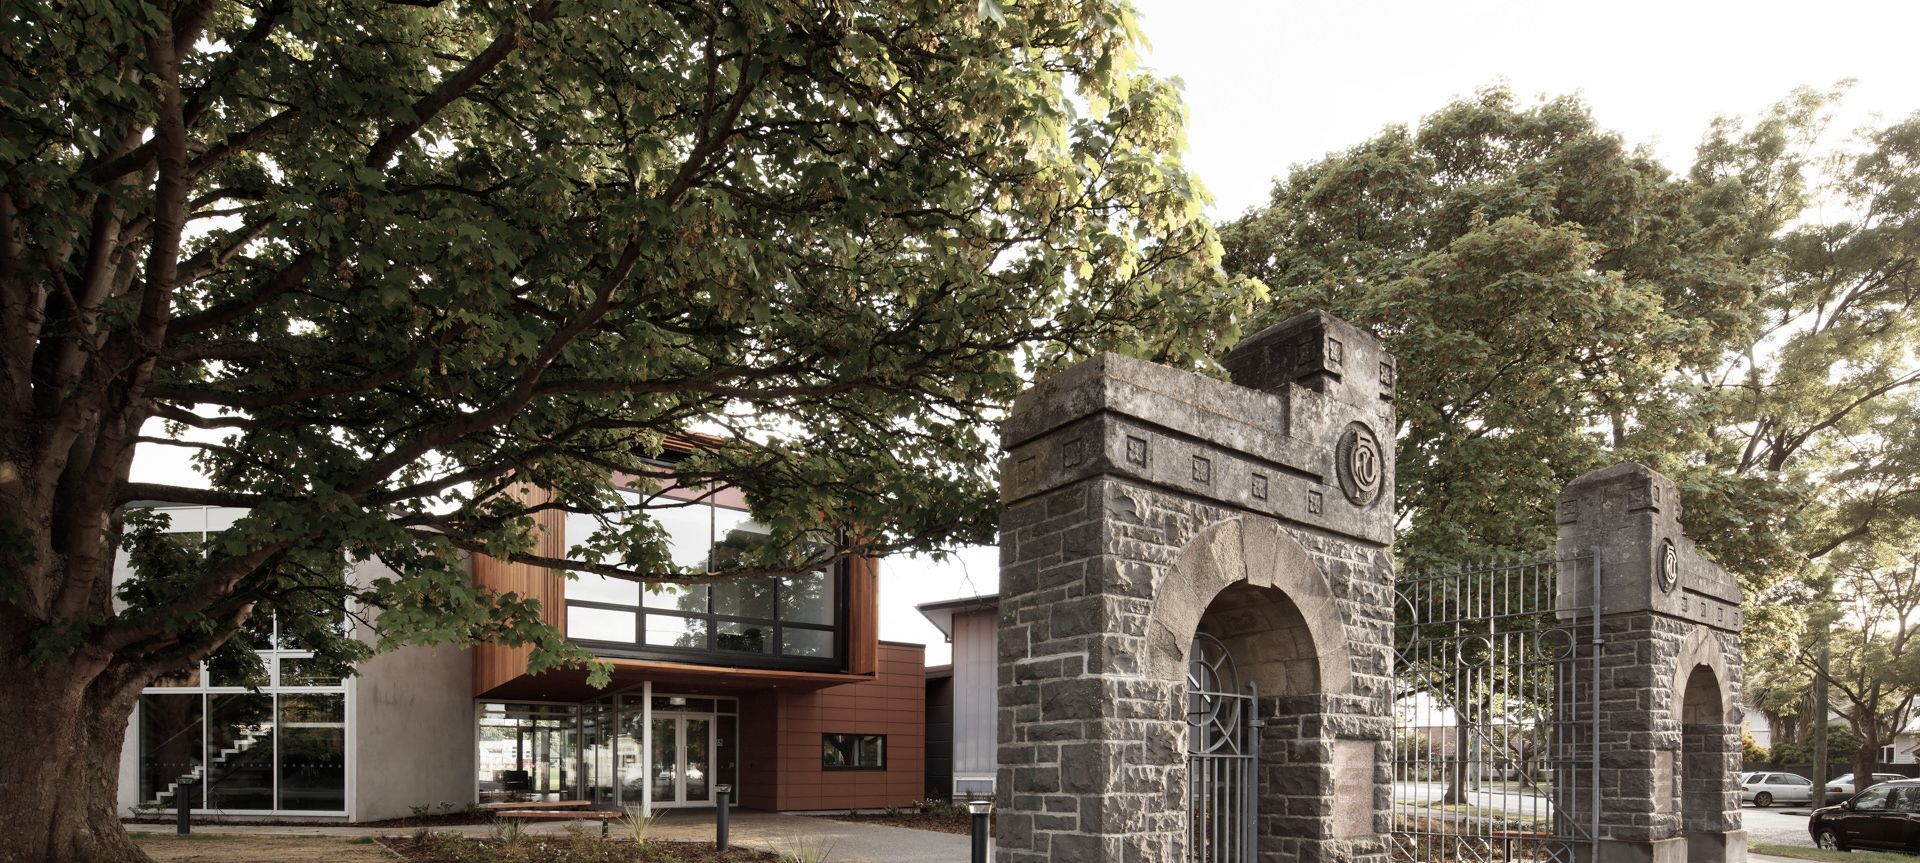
121,492 -> 925,821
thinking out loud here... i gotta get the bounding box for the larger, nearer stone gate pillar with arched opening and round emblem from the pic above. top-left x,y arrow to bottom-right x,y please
996,313 -> 1394,863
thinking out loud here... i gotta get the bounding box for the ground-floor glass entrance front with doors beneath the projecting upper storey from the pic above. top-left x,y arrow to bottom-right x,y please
476,694 -> 739,807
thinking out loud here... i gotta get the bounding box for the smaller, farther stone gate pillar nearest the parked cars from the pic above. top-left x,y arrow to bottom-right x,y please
1557,463 -> 1745,863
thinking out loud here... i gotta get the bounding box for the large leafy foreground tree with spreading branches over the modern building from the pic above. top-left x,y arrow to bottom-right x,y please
0,0 -> 1258,861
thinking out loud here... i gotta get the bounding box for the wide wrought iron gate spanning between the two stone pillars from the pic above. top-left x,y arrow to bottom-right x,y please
1390,557 -> 1601,863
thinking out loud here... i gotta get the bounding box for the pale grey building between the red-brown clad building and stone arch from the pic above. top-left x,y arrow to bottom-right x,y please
918,594 -> 1000,800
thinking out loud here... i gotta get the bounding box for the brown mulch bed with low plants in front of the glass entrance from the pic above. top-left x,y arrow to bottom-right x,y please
378,830 -> 780,863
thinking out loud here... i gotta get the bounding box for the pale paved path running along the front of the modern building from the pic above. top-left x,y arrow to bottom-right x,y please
127,809 -> 970,863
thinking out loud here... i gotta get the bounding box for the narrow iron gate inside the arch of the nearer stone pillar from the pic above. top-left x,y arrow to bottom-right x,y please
1187,632 -> 1263,863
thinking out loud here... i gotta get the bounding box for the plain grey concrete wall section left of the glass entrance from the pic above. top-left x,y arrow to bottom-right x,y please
348,561 -> 474,821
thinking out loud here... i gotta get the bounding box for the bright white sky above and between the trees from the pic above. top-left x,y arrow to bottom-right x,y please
134,0 -> 1920,665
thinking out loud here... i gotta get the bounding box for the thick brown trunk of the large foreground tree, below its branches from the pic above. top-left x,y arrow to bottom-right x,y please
0,657 -> 150,863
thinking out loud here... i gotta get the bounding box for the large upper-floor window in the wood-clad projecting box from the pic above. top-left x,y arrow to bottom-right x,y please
566,492 -> 839,669
